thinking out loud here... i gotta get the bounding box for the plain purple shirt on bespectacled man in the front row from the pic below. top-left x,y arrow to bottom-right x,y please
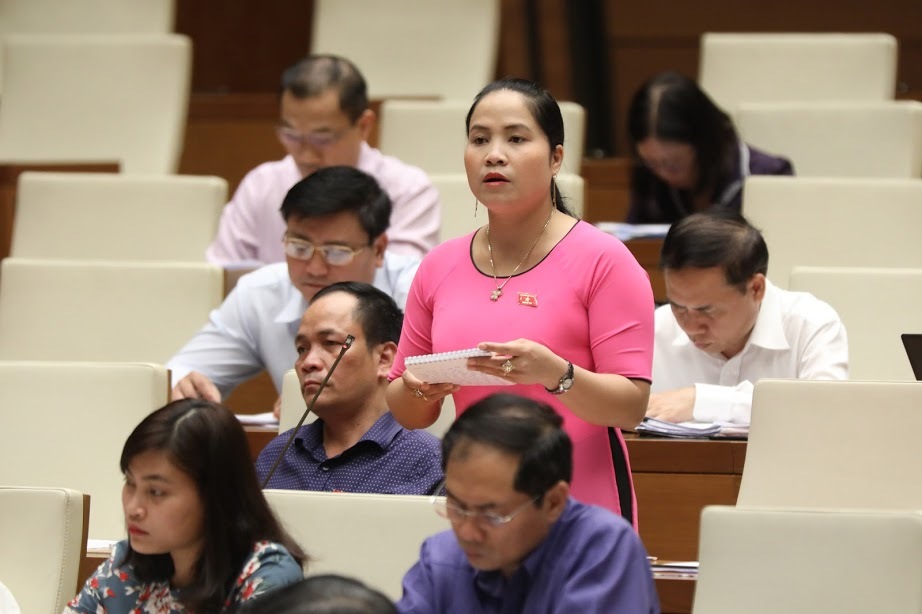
397,499 -> 659,614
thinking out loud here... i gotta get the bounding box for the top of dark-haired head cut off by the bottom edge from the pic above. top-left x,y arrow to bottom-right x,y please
232,574 -> 397,614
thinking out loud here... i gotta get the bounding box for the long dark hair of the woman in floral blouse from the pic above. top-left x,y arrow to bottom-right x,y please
119,399 -> 306,612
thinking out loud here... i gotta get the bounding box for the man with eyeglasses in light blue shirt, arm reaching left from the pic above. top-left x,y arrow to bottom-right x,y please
167,166 -> 419,412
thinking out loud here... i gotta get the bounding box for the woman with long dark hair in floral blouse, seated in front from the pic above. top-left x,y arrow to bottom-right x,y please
64,399 -> 306,614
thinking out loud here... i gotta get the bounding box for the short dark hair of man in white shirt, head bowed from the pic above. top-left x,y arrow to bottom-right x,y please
660,210 -> 768,292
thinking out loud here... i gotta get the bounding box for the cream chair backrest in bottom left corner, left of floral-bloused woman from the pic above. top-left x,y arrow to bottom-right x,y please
0,486 -> 89,614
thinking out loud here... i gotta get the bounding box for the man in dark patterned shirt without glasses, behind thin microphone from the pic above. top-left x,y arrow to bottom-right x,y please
256,282 -> 442,495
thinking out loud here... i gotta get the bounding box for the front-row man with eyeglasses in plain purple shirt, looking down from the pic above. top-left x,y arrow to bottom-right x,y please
397,394 -> 659,614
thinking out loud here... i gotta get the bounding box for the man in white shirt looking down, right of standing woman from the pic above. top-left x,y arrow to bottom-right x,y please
647,212 -> 848,424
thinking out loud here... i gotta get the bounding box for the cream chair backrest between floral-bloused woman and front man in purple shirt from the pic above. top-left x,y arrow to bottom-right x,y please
264,490 -> 450,599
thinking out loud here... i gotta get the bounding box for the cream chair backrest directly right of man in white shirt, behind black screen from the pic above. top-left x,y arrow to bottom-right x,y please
791,268 -> 922,381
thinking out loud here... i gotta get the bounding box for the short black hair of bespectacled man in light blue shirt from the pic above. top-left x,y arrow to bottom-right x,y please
280,166 -> 391,244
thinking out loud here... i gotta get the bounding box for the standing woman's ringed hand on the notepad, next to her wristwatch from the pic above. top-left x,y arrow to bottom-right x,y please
467,339 -> 567,388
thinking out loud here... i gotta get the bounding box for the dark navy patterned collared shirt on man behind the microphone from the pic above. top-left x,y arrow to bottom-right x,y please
256,412 -> 442,495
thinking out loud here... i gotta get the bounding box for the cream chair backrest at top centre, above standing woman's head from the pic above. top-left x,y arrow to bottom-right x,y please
311,0 -> 500,100
